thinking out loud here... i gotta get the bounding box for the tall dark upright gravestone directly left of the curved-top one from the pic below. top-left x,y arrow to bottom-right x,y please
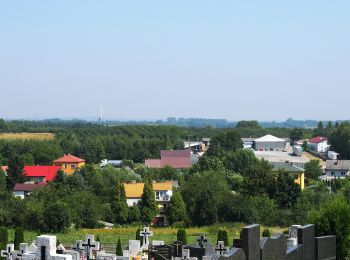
241,225 -> 260,260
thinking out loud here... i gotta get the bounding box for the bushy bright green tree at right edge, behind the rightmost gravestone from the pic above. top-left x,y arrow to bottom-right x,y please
309,197 -> 350,259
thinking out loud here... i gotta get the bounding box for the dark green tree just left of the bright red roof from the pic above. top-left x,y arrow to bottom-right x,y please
7,155 -> 26,191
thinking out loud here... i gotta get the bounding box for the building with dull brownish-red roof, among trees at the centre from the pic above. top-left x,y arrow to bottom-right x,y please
145,149 -> 195,169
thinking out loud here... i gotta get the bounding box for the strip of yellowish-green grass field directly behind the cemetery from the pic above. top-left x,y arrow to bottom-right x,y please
9,223 -> 287,252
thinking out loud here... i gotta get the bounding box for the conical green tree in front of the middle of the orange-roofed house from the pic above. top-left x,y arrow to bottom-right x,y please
141,181 -> 158,224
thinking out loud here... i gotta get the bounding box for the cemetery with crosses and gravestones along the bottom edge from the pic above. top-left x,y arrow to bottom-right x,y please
1,224 -> 336,260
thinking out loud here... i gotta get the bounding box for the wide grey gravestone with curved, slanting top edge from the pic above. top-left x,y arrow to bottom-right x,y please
260,234 -> 287,260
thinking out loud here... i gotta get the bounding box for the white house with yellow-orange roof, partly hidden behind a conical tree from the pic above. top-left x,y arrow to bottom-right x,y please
124,181 -> 178,226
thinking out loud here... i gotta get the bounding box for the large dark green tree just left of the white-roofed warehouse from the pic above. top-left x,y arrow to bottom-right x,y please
207,130 -> 243,157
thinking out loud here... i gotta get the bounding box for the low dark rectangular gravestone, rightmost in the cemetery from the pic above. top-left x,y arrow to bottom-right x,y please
315,236 -> 337,260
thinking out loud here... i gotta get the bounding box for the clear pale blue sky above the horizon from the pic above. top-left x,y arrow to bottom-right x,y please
0,0 -> 350,120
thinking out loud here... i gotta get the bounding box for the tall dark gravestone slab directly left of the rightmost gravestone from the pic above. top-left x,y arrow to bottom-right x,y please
298,225 -> 315,260
